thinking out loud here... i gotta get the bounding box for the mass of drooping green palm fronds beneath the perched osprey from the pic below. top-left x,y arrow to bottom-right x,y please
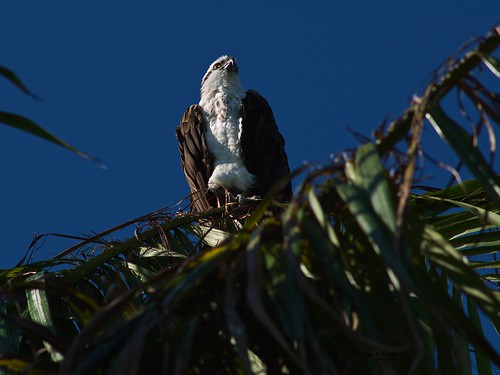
0,28 -> 500,374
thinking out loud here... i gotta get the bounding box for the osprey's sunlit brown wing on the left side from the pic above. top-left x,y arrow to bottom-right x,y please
175,105 -> 216,212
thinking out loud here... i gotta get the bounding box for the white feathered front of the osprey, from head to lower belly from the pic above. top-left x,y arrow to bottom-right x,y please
199,56 -> 255,192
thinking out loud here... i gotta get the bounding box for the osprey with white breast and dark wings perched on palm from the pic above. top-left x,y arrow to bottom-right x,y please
176,55 -> 292,211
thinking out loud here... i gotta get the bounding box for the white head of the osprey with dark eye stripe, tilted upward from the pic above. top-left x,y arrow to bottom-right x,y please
201,55 -> 242,98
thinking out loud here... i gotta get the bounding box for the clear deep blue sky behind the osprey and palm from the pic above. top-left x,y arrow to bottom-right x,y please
0,0 -> 500,268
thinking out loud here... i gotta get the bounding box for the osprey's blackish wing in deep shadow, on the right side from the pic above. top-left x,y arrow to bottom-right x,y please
241,90 -> 292,201
